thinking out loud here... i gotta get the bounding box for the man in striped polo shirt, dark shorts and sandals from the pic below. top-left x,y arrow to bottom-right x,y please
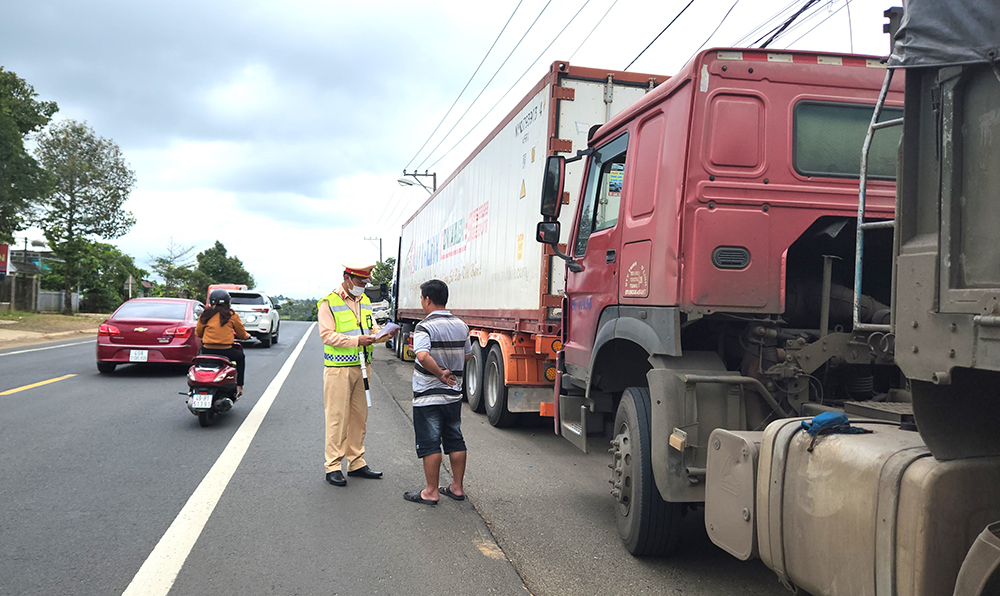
403,279 -> 472,505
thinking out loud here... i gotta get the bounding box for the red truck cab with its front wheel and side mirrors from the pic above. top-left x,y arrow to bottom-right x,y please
536,49 -> 902,554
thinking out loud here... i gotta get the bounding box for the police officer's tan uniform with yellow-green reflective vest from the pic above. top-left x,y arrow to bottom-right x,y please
318,267 -> 387,472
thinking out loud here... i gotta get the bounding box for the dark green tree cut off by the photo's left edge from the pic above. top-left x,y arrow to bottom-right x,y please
0,67 -> 59,243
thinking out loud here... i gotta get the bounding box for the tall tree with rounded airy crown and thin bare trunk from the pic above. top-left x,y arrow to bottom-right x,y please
37,120 -> 135,314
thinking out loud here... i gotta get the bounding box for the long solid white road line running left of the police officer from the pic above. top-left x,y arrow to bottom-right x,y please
122,323 -> 316,596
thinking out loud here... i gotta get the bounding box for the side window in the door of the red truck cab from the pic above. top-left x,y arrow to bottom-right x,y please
573,134 -> 628,257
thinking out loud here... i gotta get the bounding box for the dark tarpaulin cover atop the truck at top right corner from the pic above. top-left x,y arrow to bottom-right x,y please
889,0 -> 1000,68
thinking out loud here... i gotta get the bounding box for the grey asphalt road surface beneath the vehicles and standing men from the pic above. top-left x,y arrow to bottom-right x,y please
0,321 -> 785,596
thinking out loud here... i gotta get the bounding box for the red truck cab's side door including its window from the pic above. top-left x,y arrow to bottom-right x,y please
564,133 -> 628,376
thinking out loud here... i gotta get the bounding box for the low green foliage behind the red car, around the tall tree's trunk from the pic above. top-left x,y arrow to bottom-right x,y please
42,241 -> 148,313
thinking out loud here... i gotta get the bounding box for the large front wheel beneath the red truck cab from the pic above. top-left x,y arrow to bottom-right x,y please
611,387 -> 684,556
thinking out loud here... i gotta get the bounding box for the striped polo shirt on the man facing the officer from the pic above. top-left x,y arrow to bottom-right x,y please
413,310 -> 472,407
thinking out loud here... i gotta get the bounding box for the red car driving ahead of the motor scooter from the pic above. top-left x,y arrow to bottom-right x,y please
97,298 -> 205,373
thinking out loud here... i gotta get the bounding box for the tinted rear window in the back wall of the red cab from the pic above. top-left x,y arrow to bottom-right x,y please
793,101 -> 903,180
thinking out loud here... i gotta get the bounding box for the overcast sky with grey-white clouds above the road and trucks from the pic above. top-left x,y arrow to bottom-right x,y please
0,0 -> 898,298
